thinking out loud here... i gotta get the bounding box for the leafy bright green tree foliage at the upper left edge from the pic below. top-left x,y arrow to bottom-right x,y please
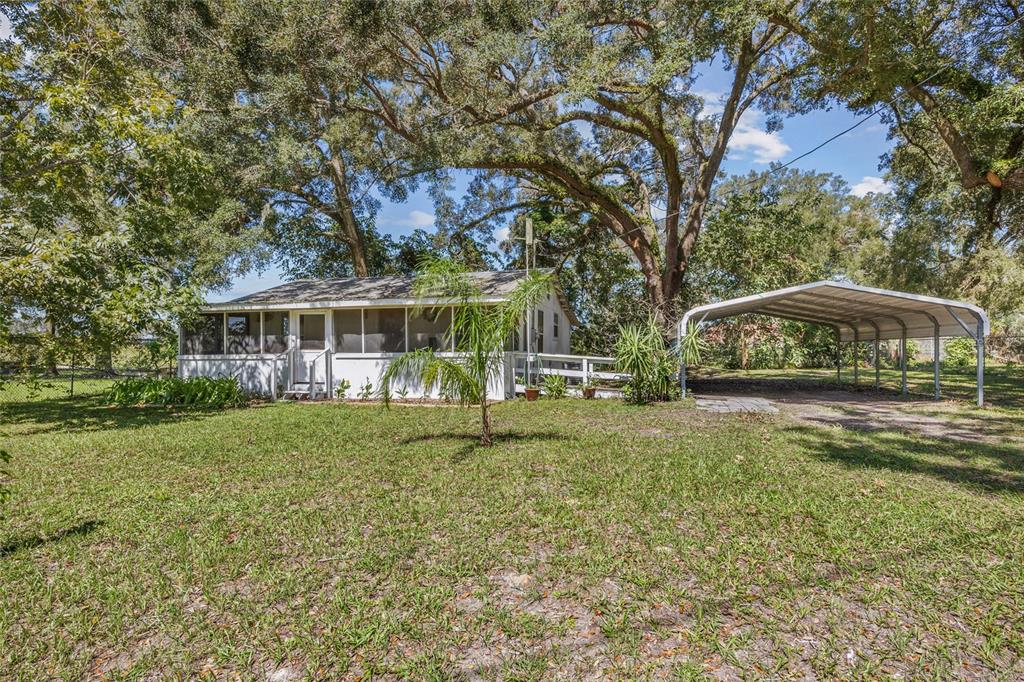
0,0 -> 249,350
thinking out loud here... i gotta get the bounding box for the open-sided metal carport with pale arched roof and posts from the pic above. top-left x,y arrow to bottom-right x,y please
678,282 -> 989,407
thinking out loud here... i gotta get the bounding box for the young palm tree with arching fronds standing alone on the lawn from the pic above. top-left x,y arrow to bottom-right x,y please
381,260 -> 551,445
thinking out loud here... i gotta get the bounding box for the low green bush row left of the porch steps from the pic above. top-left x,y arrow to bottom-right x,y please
103,377 -> 246,408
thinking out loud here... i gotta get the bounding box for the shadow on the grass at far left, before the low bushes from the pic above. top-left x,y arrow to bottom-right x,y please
0,395 -> 231,434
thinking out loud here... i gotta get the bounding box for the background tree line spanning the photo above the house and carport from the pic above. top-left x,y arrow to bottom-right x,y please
0,0 -> 1024,366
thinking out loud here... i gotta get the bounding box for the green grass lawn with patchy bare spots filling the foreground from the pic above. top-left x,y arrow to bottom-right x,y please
0,391 -> 1024,680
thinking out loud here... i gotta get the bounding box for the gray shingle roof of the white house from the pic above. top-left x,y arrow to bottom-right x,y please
216,270 -> 550,308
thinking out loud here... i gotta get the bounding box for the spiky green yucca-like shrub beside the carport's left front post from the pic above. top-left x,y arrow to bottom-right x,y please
615,317 -> 680,404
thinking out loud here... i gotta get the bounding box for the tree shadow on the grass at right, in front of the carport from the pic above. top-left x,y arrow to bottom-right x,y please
786,426 -> 1024,494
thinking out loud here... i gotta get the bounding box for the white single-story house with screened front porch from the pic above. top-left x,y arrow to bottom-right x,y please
178,270 -> 577,399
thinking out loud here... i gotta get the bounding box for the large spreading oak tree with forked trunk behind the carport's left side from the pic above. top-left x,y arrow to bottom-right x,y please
331,0 -> 802,316
